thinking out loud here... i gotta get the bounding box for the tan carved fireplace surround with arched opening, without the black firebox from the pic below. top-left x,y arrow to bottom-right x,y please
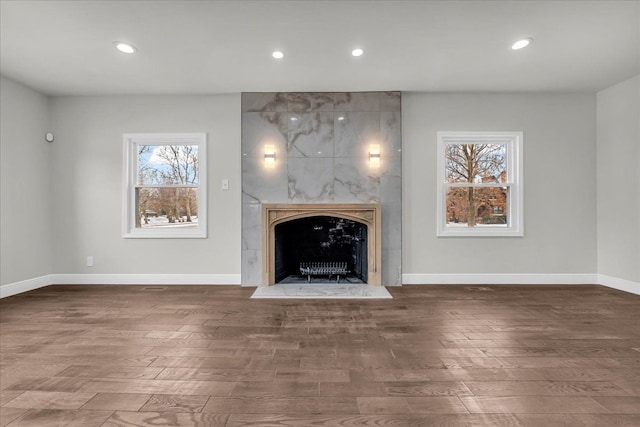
262,203 -> 382,286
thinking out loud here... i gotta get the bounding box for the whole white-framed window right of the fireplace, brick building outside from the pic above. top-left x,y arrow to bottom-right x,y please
437,132 -> 524,236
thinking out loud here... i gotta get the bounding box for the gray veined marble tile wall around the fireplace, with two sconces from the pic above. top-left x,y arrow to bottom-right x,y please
242,92 -> 402,286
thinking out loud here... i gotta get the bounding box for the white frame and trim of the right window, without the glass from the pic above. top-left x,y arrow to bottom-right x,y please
437,132 -> 524,237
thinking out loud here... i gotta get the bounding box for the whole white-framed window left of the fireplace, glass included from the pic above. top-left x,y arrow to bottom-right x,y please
123,133 -> 207,238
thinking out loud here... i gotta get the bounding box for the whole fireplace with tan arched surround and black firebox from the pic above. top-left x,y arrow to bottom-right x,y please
262,203 -> 381,285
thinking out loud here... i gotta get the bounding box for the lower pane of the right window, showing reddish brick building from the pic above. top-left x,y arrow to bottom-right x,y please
446,187 -> 509,227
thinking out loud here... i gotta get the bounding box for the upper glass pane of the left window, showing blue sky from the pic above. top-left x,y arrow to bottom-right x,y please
137,145 -> 199,185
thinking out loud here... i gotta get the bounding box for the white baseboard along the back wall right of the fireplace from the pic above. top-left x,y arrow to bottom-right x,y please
402,273 -> 598,285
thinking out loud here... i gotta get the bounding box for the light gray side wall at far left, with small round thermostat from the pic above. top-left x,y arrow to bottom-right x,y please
0,77 -> 53,285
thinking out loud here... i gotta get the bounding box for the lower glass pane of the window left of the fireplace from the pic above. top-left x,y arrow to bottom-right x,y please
136,188 -> 198,228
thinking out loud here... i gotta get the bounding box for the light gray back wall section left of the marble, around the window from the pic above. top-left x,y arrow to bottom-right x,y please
51,95 -> 241,274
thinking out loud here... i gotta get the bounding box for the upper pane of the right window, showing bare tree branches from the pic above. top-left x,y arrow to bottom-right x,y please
445,144 -> 507,183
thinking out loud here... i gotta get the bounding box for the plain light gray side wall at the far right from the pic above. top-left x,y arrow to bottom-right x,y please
597,76 -> 640,283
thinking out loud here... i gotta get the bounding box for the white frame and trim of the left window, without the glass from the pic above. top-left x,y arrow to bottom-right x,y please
122,133 -> 207,239
